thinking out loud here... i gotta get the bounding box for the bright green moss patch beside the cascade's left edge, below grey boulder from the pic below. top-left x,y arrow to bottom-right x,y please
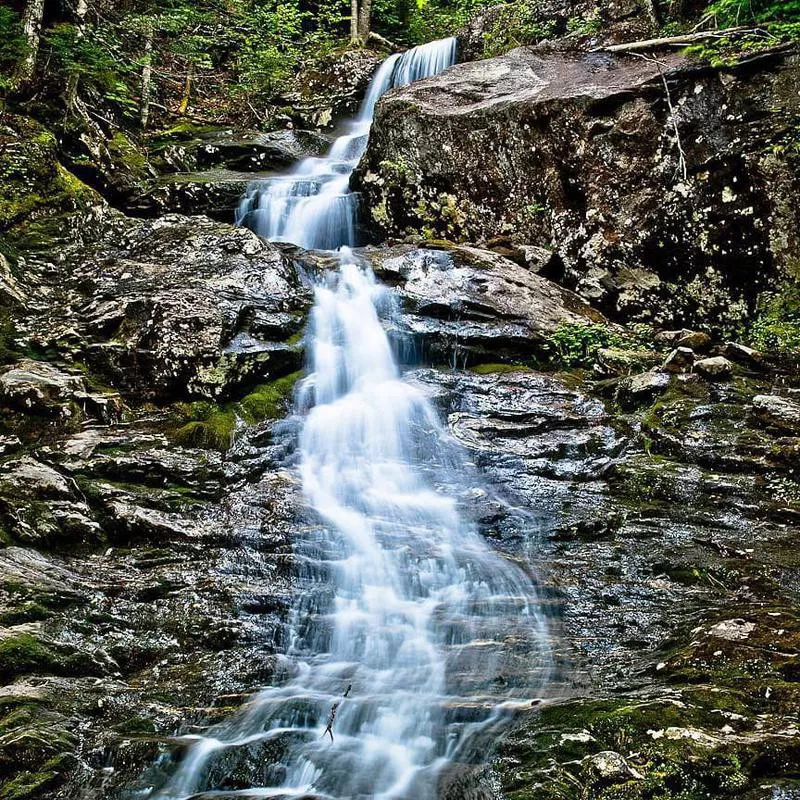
171,372 -> 302,451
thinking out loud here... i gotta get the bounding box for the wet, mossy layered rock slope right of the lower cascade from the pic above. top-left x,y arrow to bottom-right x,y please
412,370 -> 800,800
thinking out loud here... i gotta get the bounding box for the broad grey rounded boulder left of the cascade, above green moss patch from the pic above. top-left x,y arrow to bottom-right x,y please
19,215 -> 310,401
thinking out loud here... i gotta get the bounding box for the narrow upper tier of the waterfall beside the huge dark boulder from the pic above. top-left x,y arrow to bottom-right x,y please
236,38 -> 456,250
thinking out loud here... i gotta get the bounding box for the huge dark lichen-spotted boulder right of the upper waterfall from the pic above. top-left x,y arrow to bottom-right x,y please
356,48 -> 800,326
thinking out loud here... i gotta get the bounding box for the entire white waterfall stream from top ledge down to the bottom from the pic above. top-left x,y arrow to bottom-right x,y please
145,34 -> 549,800
